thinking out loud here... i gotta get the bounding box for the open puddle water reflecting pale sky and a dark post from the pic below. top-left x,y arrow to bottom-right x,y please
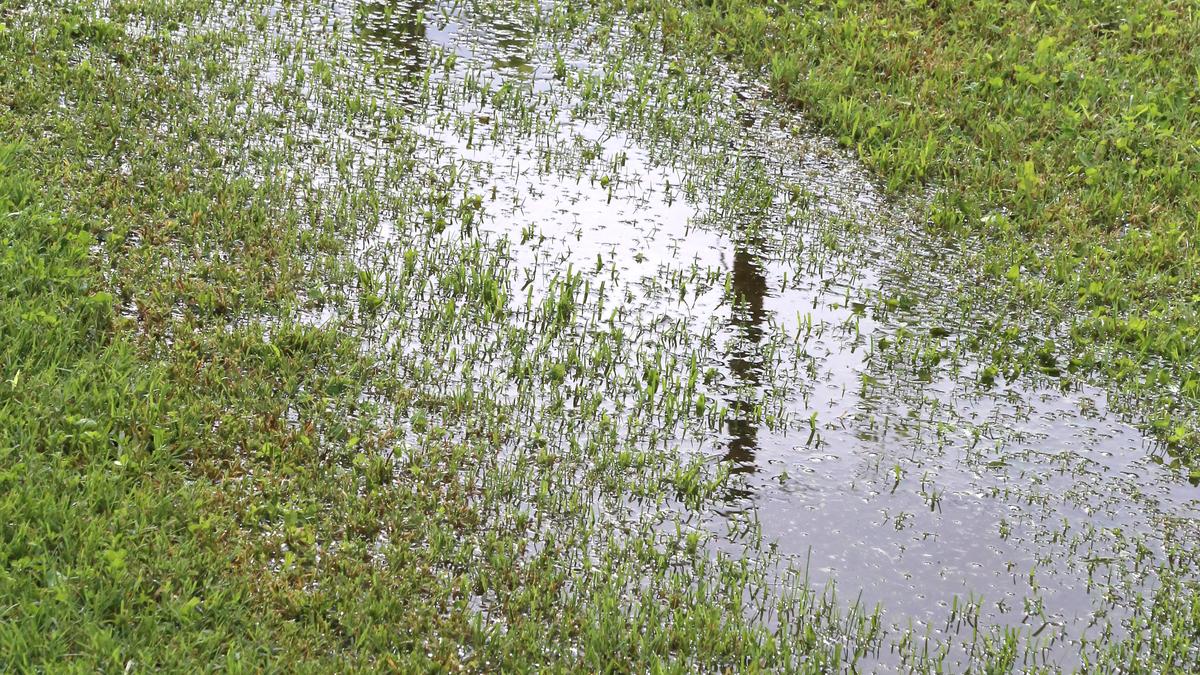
229,2 -> 1200,665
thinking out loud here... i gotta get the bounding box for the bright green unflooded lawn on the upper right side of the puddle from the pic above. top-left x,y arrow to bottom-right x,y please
623,0 -> 1200,465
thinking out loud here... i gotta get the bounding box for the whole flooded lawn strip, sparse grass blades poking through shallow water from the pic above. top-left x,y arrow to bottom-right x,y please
11,0 -> 1200,671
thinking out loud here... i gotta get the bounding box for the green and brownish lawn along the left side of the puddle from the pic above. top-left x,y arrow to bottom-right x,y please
0,2 -> 871,671
